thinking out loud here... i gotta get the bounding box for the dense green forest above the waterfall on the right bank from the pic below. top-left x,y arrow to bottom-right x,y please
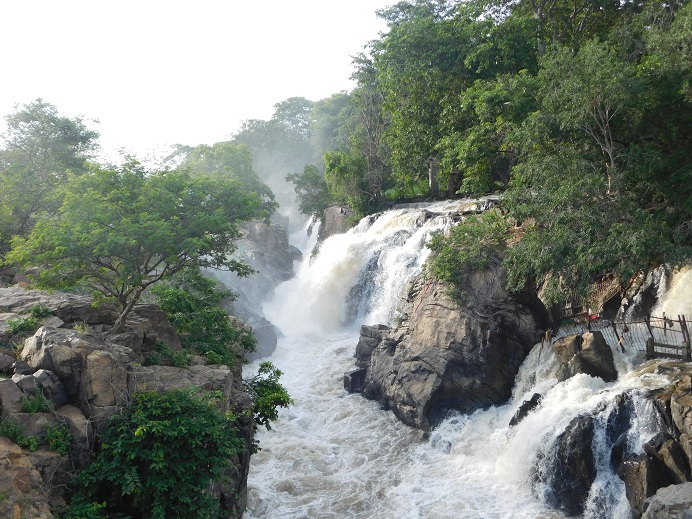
290,0 -> 692,302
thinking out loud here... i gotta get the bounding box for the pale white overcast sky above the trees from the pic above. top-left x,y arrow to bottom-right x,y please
0,0 -> 395,158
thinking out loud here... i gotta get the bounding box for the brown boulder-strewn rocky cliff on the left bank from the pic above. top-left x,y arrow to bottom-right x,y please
0,287 -> 253,519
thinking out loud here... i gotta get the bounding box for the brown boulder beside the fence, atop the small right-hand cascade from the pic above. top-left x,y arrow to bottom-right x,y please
553,331 -> 618,382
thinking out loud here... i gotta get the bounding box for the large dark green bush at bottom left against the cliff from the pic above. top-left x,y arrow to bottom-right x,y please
76,389 -> 244,519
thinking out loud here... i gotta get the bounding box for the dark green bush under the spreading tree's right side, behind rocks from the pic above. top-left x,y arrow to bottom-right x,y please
152,269 -> 257,366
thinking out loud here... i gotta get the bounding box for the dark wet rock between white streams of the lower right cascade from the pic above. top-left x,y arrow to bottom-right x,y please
544,416 -> 596,516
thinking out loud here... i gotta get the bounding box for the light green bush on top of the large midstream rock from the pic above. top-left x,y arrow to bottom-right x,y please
429,210 -> 508,301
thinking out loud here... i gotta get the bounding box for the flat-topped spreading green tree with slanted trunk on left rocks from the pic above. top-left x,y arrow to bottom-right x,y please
6,162 -> 268,331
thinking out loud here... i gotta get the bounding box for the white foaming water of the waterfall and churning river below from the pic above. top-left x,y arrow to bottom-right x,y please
246,202 -> 688,519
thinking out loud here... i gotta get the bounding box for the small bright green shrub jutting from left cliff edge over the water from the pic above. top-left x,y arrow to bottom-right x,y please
245,361 -> 293,430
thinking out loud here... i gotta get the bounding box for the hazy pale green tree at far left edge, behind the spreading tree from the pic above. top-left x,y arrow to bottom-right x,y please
0,99 -> 98,254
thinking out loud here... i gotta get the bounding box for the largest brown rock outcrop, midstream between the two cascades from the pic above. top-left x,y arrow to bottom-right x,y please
357,258 -> 547,430
